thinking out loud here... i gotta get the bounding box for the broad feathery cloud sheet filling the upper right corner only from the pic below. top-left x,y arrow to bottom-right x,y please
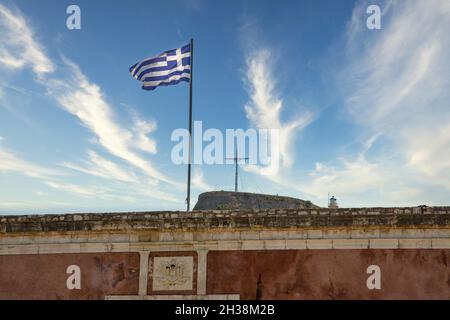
340,0 -> 450,190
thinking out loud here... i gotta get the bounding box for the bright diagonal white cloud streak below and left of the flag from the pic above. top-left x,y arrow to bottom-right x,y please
46,58 -> 177,185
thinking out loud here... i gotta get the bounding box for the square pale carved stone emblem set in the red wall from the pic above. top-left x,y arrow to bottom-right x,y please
153,257 -> 194,291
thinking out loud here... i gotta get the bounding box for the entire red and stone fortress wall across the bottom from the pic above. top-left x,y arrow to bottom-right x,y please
0,207 -> 450,299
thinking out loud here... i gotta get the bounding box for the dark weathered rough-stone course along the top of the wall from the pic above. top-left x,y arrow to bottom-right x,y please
0,207 -> 450,236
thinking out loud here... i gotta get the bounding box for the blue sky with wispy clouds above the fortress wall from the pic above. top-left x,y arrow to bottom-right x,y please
0,0 -> 450,214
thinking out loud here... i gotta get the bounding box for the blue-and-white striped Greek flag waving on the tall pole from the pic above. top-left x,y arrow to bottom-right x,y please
130,44 -> 191,90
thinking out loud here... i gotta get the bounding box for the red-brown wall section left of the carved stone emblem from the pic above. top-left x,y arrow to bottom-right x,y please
0,252 -> 139,299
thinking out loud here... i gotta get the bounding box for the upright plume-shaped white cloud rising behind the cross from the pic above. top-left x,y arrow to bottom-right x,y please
239,15 -> 315,190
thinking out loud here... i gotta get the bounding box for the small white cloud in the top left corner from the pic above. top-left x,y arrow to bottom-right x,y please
0,4 -> 55,75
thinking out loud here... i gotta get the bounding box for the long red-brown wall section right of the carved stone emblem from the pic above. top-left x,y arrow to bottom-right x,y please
207,249 -> 450,299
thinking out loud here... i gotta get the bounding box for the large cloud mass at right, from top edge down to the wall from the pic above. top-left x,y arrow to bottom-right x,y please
300,0 -> 450,205
